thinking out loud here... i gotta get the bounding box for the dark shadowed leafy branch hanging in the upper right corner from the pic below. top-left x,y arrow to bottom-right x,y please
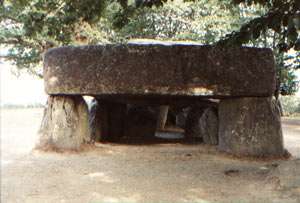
218,0 -> 300,52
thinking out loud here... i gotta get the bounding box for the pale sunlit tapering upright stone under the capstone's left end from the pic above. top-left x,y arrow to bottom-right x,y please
36,96 -> 90,149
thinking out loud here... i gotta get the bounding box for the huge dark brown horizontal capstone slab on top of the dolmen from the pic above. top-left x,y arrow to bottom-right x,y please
44,44 -> 275,98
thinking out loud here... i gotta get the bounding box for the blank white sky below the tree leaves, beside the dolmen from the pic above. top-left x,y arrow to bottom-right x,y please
0,59 -> 300,105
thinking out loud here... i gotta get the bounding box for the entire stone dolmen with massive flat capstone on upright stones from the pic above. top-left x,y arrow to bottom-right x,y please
37,43 -> 285,157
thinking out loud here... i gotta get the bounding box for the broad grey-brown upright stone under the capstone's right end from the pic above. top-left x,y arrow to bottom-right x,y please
218,97 -> 284,157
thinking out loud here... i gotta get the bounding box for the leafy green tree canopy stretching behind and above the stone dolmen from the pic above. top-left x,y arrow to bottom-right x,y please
0,0 -> 300,94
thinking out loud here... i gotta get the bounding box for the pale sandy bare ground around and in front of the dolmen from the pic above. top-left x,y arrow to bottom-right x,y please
1,109 -> 300,203
